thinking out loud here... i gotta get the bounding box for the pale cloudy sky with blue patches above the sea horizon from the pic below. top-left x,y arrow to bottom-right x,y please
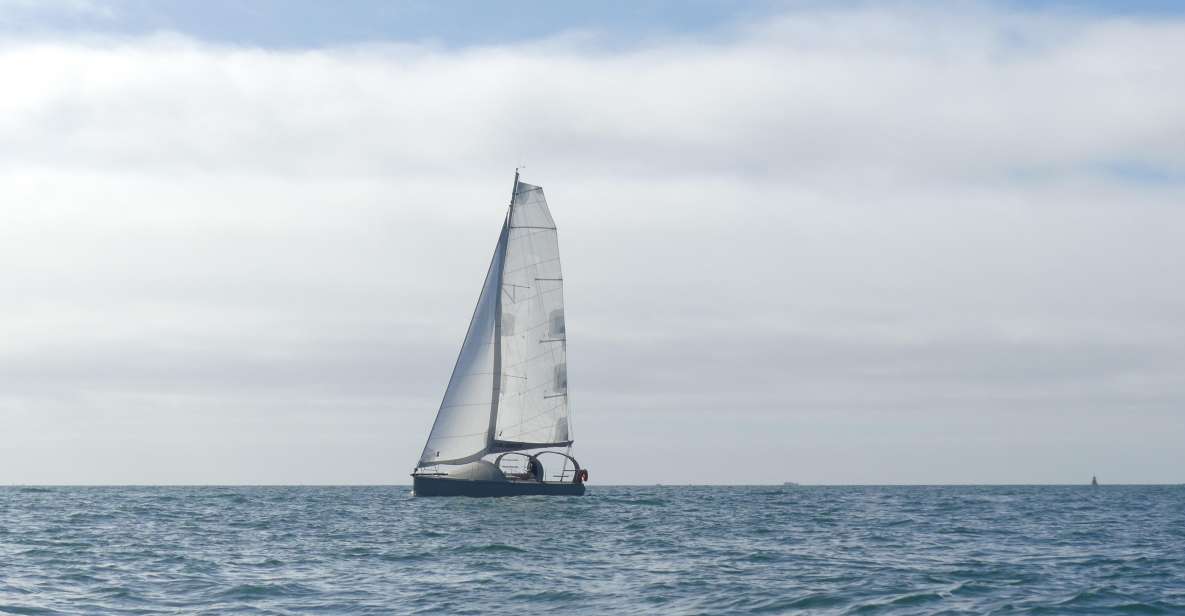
0,0 -> 1185,485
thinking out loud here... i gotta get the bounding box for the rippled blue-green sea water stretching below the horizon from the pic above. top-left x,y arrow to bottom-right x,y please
0,485 -> 1185,615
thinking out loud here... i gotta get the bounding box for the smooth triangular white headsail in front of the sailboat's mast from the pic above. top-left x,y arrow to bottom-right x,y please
419,220 -> 510,466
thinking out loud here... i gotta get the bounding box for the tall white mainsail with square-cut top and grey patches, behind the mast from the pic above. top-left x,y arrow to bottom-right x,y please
491,182 -> 571,451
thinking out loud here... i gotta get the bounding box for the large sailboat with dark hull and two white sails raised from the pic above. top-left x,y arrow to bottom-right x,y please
411,169 -> 588,496
